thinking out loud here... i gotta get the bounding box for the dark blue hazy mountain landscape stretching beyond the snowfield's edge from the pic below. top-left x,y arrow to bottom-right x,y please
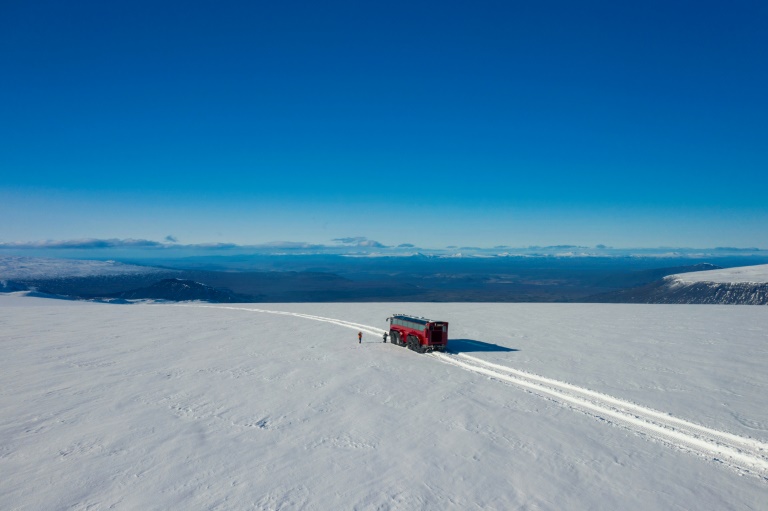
0,257 -> 768,304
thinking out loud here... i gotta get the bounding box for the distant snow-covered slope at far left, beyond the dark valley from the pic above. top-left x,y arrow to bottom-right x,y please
0,256 -> 166,279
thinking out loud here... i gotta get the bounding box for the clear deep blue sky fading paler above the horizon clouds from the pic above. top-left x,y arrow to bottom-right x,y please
0,0 -> 768,248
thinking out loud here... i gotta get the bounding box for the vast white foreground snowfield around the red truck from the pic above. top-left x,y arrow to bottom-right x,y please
0,293 -> 768,511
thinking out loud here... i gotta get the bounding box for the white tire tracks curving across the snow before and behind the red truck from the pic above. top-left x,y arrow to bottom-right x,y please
171,304 -> 768,480
